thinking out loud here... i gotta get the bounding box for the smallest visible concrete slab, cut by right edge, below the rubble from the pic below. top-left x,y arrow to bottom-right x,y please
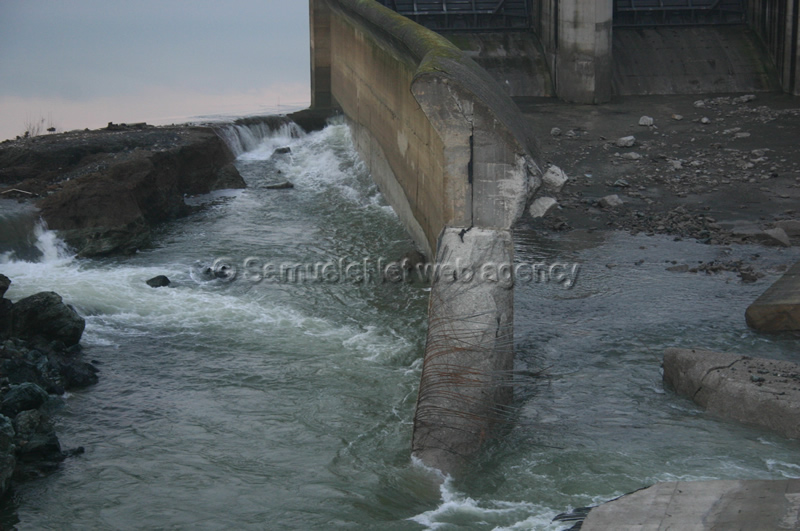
744,262 -> 800,332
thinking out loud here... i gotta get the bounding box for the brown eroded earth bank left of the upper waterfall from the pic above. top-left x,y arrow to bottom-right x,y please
0,123 -> 245,257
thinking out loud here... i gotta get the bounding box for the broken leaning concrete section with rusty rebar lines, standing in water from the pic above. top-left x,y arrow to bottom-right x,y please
412,227 -> 514,475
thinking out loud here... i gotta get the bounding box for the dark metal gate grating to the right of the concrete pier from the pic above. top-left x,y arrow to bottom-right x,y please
614,0 -> 745,26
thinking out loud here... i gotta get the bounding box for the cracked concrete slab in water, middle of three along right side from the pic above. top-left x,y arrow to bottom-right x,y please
664,348 -> 800,439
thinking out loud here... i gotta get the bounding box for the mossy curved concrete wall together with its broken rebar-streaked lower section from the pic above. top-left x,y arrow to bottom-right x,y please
310,0 -> 541,472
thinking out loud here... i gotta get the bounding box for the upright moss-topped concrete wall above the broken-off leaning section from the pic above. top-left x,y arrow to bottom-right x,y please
311,0 -> 538,256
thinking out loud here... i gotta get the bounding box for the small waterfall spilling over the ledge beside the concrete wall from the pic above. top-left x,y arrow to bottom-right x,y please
217,116 -> 305,157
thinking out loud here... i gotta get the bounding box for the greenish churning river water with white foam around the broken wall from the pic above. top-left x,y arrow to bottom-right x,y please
0,118 -> 800,529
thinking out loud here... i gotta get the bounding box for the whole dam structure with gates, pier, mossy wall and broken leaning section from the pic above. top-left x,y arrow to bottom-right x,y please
309,0 -> 800,473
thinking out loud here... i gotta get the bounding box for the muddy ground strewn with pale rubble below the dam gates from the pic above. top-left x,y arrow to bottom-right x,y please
522,94 -> 800,246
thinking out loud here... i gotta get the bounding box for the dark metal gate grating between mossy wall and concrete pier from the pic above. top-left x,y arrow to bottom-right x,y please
378,0 -> 530,31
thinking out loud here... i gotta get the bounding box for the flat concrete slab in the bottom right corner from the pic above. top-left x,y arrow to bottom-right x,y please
581,479 -> 800,531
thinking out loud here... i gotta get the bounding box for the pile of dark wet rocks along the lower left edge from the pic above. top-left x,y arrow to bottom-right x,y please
0,274 -> 98,495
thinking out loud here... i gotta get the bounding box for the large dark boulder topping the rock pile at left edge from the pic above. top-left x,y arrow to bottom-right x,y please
12,291 -> 86,345
